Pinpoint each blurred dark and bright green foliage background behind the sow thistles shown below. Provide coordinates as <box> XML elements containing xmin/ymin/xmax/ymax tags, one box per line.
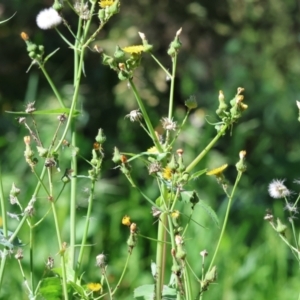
<box><xmin>0</xmin><ymin>0</ymin><xmax>300</xmax><ymax>300</ymax></box>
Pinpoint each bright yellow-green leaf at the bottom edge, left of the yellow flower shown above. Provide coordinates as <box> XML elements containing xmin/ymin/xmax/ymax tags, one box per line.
<box><xmin>38</xmin><ymin>277</ymin><xmax>62</xmax><ymax>300</ymax></box>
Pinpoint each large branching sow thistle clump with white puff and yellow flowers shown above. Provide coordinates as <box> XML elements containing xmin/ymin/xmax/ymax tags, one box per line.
<box><xmin>0</xmin><ymin>0</ymin><xmax>247</xmax><ymax>300</ymax></box>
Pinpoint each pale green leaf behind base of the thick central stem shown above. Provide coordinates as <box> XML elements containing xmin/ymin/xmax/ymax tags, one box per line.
<box><xmin>133</xmin><ymin>284</ymin><xmax>176</xmax><ymax>300</ymax></box>
